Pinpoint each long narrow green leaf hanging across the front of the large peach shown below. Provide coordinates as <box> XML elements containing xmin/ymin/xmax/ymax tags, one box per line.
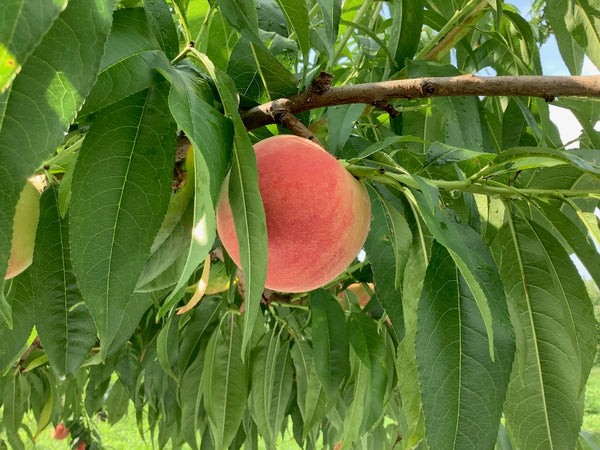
<box><xmin>196</xmin><ymin>53</ymin><xmax>268</xmax><ymax>353</ymax></box>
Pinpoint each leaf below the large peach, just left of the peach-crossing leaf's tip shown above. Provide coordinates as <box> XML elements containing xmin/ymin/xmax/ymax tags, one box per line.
<box><xmin>201</xmin><ymin>314</ymin><xmax>248</xmax><ymax>448</ymax></box>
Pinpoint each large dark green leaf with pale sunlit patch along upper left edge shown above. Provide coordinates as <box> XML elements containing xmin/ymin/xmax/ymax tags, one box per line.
<box><xmin>0</xmin><ymin>0</ymin><xmax>112</xmax><ymax>323</ymax></box>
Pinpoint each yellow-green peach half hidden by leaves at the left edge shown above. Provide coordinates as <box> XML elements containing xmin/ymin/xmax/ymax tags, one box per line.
<box><xmin>4</xmin><ymin>182</ymin><xmax>40</xmax><ymax>280</ymax></box>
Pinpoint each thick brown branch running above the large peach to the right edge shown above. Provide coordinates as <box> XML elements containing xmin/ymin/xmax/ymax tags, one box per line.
<box><xmin>242</xmin><ymin>73</ymin><xmax>600</xmax><ymax>130</ymax></box>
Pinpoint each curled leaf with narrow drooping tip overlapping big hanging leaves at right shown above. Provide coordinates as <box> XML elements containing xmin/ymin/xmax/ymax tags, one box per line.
<box><xmin>413</xmin><ymin>178</ymin><xmax>510</xmax><ymax>359</ymax></box>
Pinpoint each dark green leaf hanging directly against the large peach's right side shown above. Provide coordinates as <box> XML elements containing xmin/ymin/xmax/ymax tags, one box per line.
<box><xmin>365</xmin><ymin>189</ymin><xmax>412</xmax><ymax>338</ymax></box>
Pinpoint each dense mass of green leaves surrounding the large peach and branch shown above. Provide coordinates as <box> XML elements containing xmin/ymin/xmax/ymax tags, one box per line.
<box><xmin>0</xmin><ymin>0</ymin><xmax>600</xmax><ymax>449</ymax></box>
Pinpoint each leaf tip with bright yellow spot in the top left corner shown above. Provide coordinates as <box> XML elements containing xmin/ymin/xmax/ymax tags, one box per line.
<box><xmin>0</xmin><ymin>0</ymin><xmax>67</xmax><ymax>92</ymax></box>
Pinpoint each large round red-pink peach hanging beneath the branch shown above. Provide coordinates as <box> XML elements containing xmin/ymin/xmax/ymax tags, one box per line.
<box><xmin>217</xmin><ymin>135</ymin><xmax>371</xmax><ymax>292</ymax></box>
